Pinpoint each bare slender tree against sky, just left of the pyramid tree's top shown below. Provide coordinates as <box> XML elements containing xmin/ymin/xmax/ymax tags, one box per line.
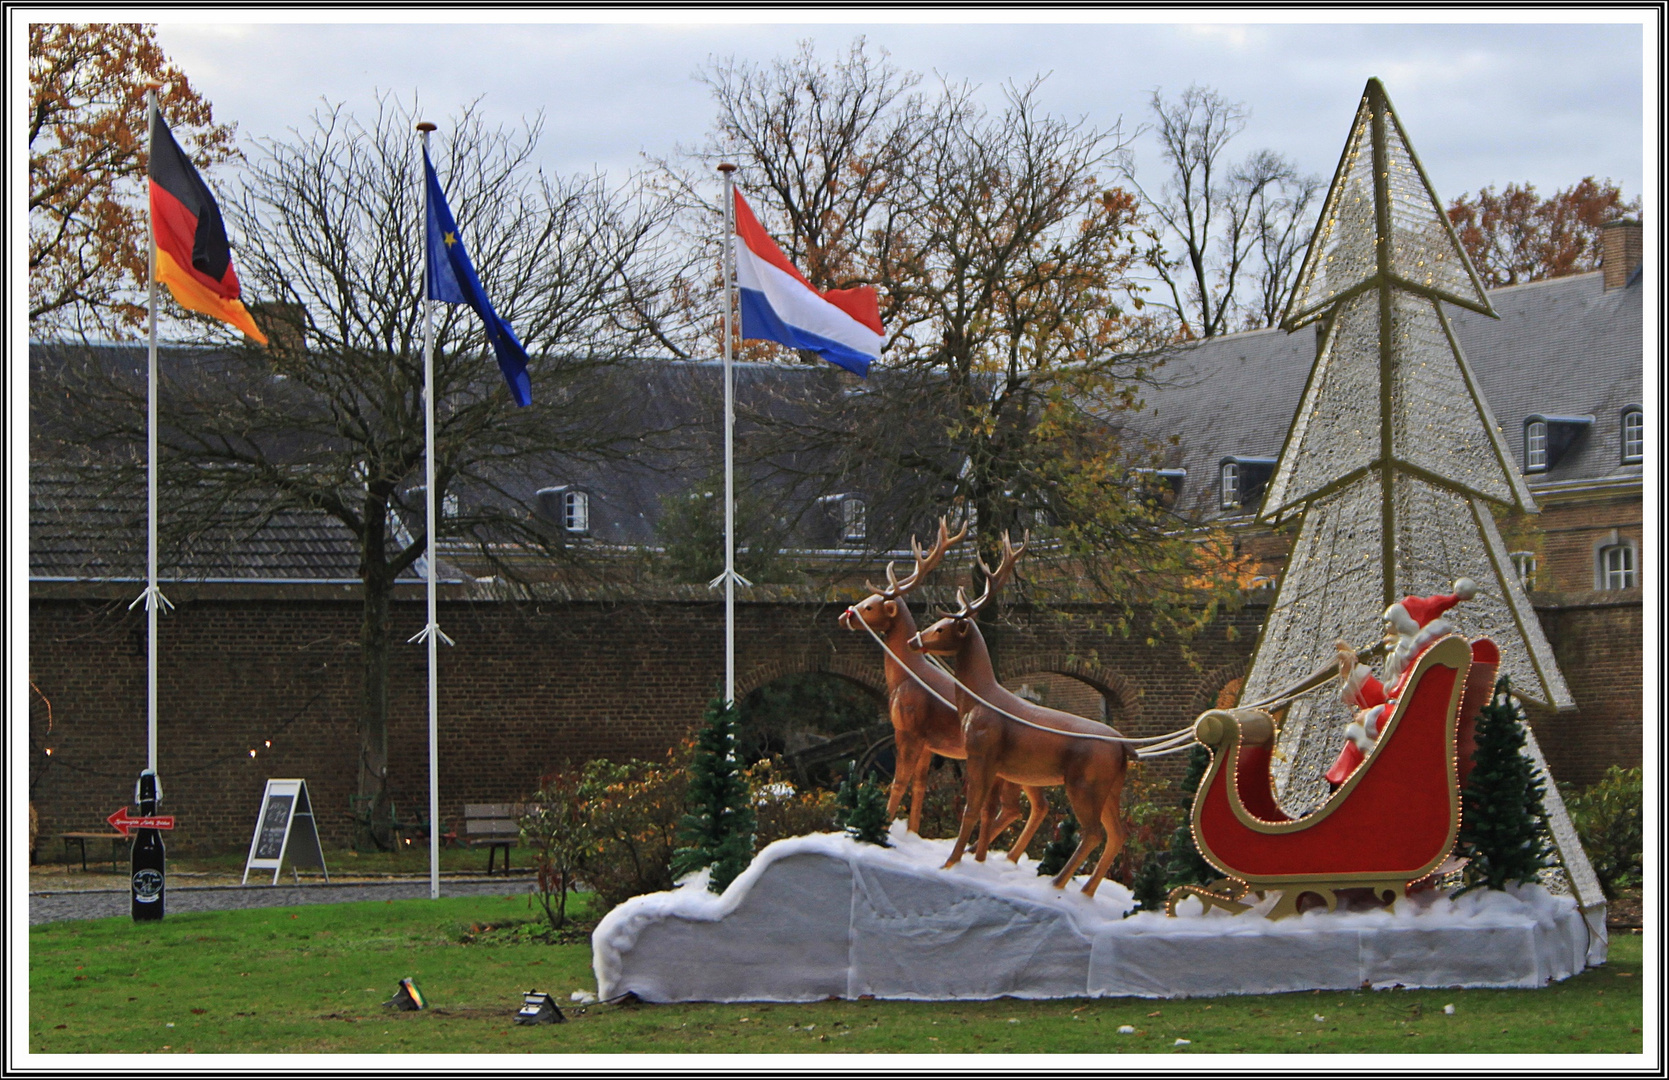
<box><xmin>1142</xmin><ymin>85</ymin><xmax>1320</xmax><ymax>337</ymax></box>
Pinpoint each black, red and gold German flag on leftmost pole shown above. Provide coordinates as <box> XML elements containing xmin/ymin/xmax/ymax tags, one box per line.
<box><xmin>149</xmin><ymin>105</ymin><xmax>267</xmax><ymax>344</ymax></box>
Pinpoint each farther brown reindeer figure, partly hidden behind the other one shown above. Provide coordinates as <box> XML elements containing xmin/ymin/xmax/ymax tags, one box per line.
<box><xmin>840</xmin><ymin>517</ymin><xmax>1020</xmax><ymax>836</ymax></box>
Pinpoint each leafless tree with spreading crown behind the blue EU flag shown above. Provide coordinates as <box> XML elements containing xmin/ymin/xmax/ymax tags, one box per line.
<box><xmin>39</xmin><ymin>98</ymin><xmax>690</xmax><ymax>837</ymax></box>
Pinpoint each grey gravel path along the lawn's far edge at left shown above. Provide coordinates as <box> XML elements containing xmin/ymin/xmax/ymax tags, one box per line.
<box><xmin>28</xmin><ymin>878</ymin><xmax>532</xmax><ymax>926</ymax></box>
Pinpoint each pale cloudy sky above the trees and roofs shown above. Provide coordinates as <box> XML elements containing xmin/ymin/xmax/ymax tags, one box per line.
<box><xmin>146</xmin><ymin>10</ymin><xmax>1656</xmax><ymax>200</ymax></box>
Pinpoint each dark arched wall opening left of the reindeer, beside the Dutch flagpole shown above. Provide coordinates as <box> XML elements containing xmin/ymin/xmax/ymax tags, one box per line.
<box><xmin>738</xmin><ymin>671</ymin><xmax>893</xmax><ymax>788</ymax></box>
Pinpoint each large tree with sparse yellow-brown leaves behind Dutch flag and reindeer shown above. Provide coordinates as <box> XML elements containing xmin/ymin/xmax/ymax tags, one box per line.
<box><xmin>691</xmin><ymin>42</ymin><xmax>1255</xmax><ymax>640</ymax></box>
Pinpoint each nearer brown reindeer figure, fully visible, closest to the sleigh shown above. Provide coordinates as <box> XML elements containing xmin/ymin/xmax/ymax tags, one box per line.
<box><xmin>910</xmin><ymin>534</ymin><xmax>1135</xmax><ymax>896</ymax></box>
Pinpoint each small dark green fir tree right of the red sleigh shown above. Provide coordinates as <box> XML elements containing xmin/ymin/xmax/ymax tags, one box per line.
<box><xmin>1455</xmin><ymin>679</ymin><xmax>1552</xmax><ymax>891</ymax></box>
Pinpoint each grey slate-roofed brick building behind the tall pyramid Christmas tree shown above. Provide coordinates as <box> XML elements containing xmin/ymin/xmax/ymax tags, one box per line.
<box><xmin>1132</xmin><ymin>237</ymin><xmax>1646</xmax><ymax>604</ymax></box>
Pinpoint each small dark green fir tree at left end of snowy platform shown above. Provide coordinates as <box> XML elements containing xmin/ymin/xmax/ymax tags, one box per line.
<box><xmin>673</xmin><ymin>698</ymin><xmax>754</xmax><ymax>893</ymax></box>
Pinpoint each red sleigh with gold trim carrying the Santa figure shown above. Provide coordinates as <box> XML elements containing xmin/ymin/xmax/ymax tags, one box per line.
<box><xmin>1167</xmin><ymin>634</ymin><xmax>1500</xmax><ymax>918</ymax></box>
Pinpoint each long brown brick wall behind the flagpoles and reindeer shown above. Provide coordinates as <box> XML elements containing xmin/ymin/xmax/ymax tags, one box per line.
<box><xmin>30</xmin><ymin>586</ymin><xmax>1641</xmax><ymax>856</ymax></box>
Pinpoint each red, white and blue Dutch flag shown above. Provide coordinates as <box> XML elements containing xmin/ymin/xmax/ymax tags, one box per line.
<box><xmin>734</xmin><ymin>192</ymin><xmax>885</xmax><ymax>377</ymax></box>
